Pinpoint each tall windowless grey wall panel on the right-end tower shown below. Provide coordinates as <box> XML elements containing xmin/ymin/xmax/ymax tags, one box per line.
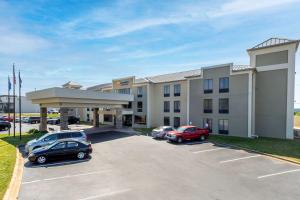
<box><xmin>255</xmin><ymin>69</ymin><xmax>287</xmax><ymax>138</ymax></box>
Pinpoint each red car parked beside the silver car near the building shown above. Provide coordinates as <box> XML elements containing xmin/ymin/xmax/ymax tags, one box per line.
<box><xmin>166</xmin><ymin>126</ymin><xmax>209</xmax><ymax>143</ymax></box>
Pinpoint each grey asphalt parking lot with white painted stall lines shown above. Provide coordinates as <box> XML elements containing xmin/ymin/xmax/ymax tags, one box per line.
<box><xmin>19</xmin><ymin>132</ymin><xmax>300</xmax><ymax>200</ymax></box>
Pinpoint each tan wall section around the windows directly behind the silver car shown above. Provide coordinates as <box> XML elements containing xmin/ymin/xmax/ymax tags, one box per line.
<box><xmin>151</xmin><ymin>81</ymin><xmax>187</xmax><ymax>127</ymax></box>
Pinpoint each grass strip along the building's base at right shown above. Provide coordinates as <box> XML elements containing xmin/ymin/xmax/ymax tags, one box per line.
<box><xmin>209</xmin><ymin>135</ymin><xmax>300</xmax><ymax>164</ymax></box>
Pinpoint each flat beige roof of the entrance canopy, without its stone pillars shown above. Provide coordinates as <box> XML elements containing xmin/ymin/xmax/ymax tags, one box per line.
<box><xmin>26</xmin><ymin>87</ymin><xmax>134</xmax><ymax>108</ymax></box>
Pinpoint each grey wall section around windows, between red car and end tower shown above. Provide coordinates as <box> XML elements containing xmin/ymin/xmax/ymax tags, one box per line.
<box><xmin>189</xmin><ymin>66</ymin><xmax>248</xmax><ymax>137</ymax></box>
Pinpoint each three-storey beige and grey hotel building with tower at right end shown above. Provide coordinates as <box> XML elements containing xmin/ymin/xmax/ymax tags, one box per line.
<box><xmin>82</xmin><ymin>38</ymin><xmax>299</xmax><ymax>138</ymax></box>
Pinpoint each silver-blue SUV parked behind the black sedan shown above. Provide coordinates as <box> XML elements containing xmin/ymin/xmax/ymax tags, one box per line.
<box><xmin>25</xmin><ymin>131</ymin><xmax>87</xmax><ymax>153</ymax></box>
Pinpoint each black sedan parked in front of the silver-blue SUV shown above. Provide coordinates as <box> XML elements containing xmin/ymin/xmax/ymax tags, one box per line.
<box><xmin>28</xmin><ymin>139</ymin><xmax>93</xmax><ymax>164</ymax></box>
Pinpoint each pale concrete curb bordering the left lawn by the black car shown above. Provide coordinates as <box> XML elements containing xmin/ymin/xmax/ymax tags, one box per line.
<box><xmin>3</xmin><ymin>147</ymin><xmax>24</xmax><ymax>200</ymax></box>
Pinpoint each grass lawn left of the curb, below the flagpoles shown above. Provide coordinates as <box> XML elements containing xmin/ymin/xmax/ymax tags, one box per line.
<box><xmin>0</xmin><ymin>133</ymin><xmax>42</xmax><ymax>199</ymax></box>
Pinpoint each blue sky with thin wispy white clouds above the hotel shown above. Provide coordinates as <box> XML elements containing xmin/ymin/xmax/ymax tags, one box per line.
<box><xmin>0</xmin><ymin>0</ymin><xmax>300</xmax><ymax>107</ymax></box>
